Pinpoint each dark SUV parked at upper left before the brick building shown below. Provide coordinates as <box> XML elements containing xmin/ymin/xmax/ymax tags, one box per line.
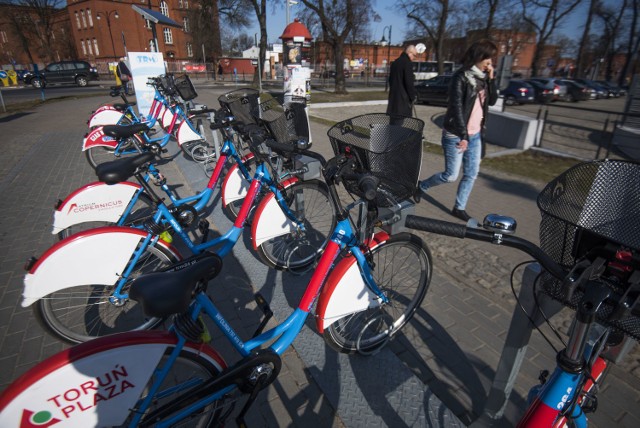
<box><xmin>23</xmin><ymin>61</ymin><xmax>100</xmax><ymax>88</ymax></box>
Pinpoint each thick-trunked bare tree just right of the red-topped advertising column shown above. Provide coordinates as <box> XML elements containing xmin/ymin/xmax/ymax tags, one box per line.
<box><xmin>302</xmin><ymin>0</ymin><xmax>371</xmax><ymax>94</ymax></box>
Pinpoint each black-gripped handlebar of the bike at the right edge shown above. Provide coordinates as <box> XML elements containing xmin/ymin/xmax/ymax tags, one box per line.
<box><xmin>405</xmin><ymin>215</ymin><xmax>567</xmax><ymax>280</ymax></box>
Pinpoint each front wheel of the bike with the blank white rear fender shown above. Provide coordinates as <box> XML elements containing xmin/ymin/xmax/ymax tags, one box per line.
<box><xmin>255</xmin><ymin>180</ymin><xmax>336</xmax><ymax>271</ymax></box>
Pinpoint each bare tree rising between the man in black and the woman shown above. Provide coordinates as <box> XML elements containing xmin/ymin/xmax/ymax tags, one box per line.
<box><xmin>398</xmin><ymin>0</ymin><xmax>450</xmax><ymax>74</ymax></box>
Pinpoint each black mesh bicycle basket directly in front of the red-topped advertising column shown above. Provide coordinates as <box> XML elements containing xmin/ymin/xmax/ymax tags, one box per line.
<box><xmin>253</xmin><ymin>97</ymin><xmax>309</xmax><ymax>145</ymax></box>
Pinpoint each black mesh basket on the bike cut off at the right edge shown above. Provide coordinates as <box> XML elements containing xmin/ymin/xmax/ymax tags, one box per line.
<box><xmin>538</xmin><ymin>160</ymin><xmax>640</xmax><ymax>339</ymax></box>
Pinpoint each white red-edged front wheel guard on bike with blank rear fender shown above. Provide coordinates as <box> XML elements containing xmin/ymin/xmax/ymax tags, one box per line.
<box><xmin>251</xmin><ymin>177</ymin><xmax>300</xmax><ymax>250</ymax></box>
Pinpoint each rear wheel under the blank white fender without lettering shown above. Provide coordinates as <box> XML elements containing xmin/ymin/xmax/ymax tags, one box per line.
<box><xmin>34</xmin><ymin>242</ymin><xmax>177</xmax><ymax>343</ymax></box>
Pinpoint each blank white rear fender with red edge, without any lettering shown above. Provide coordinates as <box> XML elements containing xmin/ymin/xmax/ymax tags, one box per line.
<box><xmin>22</xmin><ymin>226</ymin><xmax>182</xmax><ymax>307</ymax></box>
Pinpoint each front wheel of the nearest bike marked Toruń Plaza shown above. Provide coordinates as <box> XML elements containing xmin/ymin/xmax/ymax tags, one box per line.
<box><xmin>324</xmin><ymin>233</ymin><xmax>432</xmax><ymax>354</ymax></box>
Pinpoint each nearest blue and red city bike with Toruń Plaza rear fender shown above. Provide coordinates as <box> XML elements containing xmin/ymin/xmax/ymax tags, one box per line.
<box><xmin>0</xmin><ymin>115</ymin><xmax>431</xmax><ymax>427</ymax></box>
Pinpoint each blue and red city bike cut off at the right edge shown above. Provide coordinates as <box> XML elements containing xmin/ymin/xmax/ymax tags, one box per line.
<box><xmin>405</xmin><ymin>160</ymin><xmax>640</xmax><ymax>428</ymax></box>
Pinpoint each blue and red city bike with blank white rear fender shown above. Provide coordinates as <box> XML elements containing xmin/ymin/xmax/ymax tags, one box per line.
<box><xmin>22</xmin><ymin>108</ymin><xmax>335</xmax><ymax>342</ymax></box>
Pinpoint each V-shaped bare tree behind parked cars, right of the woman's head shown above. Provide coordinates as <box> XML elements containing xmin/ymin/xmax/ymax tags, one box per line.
<box><xmin>521</xmin><ymin>0</ymin><xmax>582</xmax><ymax>76</ymax></box>
